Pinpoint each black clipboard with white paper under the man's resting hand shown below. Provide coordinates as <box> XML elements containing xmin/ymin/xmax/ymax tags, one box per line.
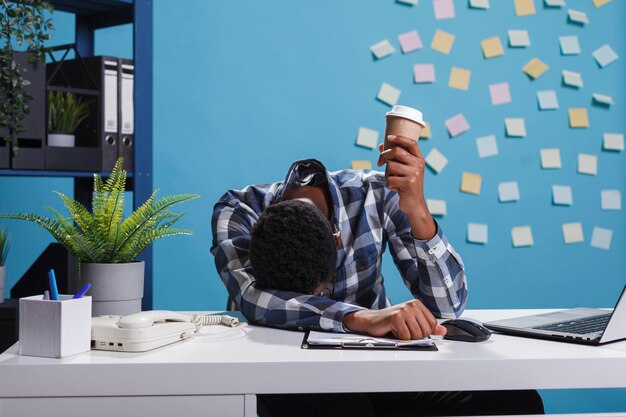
<box><xmin>301</xmin><ymin>330</ymin><xmax>439</xmax><ymax>352</ymax></box>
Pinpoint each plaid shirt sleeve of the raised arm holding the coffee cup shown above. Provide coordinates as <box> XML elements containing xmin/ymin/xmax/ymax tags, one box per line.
<box><xmin>383</xmin><ymin>190</ymin><xmax>467</xmax><ymax>318</ymax></box>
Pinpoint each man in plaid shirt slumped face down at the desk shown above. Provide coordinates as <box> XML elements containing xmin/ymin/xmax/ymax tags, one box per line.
<box><xmin>211</xmin><ymin>136</ymin><xmax>543</xmax><ymax>417</ymax></box>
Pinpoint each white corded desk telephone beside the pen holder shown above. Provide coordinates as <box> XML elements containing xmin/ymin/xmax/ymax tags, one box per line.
<box><xmin>91</xmin><ymin>310</ymin><xmax>246</xmax><ymax>352</ymax></box>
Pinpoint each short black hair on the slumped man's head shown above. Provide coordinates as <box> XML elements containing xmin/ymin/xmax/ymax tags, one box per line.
<box><xmin>250</xmin><ymin>200</ymin><xmax>337</xmax><ymax>294</ymax></box>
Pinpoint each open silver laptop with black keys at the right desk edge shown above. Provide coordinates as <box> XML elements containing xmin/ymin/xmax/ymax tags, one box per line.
<box><xmin>483</xmin><ymin>286</ymin><xmax>626</xmax><ymax>345</ymax></box>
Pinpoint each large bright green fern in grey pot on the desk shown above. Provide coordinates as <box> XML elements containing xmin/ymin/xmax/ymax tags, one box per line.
<box><xmin>0</xmin><ymin>158</ymin><xmax>199</xmax><ymax>316</ymax></box>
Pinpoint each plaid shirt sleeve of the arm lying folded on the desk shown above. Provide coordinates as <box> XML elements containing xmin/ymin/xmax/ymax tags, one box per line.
<box><xmin>211</xmin><ymin>201</ymin><xmax>362</xmax><ymax>332</ymax></box>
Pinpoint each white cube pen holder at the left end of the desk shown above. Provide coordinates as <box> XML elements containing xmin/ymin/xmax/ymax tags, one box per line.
<box><xmin>19</xmin><ymin>295</ymin><xmax>91</xmax><ymax>358</ymax></box>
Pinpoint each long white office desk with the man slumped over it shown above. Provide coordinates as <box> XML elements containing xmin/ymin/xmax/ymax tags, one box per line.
<box><xmin>0</xmin><ymin>310</ymin><xmax>626</xmax><ymax>417</ymax></box>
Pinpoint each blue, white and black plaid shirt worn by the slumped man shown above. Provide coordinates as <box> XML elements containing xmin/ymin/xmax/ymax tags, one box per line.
<box><xmin>211</xmin><ymin>160</ymin><xmax>467</xmax><ymax>332</ymax></box>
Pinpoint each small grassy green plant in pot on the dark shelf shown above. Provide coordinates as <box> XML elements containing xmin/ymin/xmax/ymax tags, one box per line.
<box><xmin>48</xmin><ymin>91</ymin><xmax>89</xmax><ymax>147</ymax></box>
